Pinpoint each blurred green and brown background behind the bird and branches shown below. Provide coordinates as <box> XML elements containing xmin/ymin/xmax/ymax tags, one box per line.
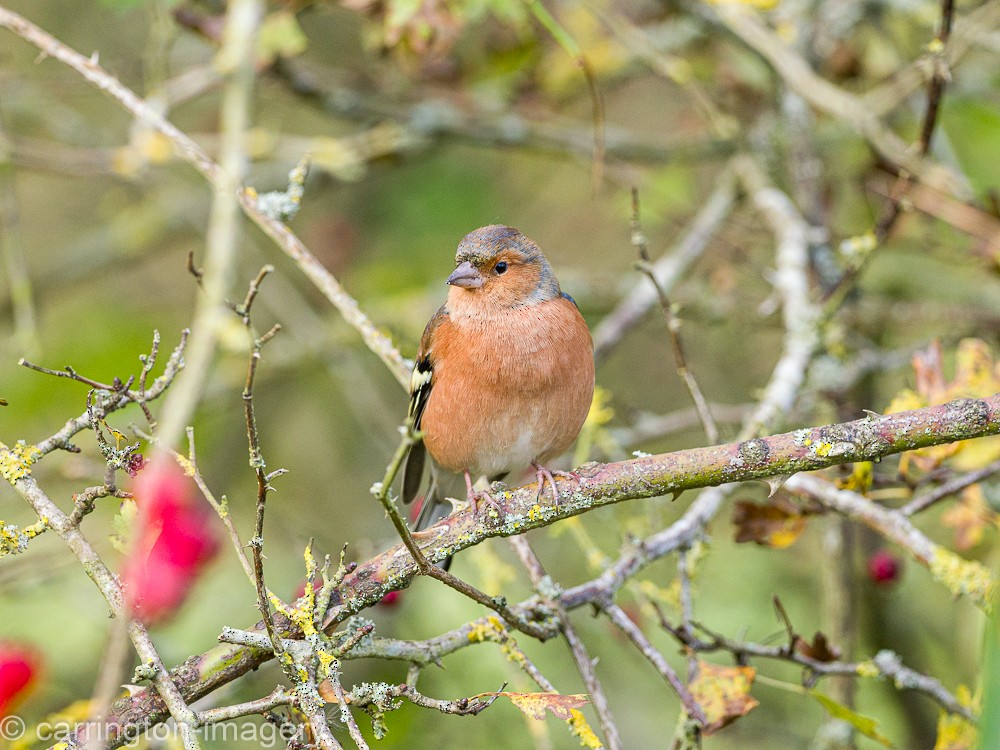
<box><xmin>0</xmin><ymin>0</ymin><xmax>1000</xmax><ymax>750</ymax></box>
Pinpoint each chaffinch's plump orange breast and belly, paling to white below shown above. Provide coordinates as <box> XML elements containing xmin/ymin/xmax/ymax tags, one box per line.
<box><xmin>421</xmin><ymin>297</ymin><xmax>594</xmax><ymax>476</ymax></box>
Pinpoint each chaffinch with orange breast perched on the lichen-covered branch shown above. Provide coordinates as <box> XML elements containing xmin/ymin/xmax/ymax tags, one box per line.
<box><xmin>402</xmin><ymin>225</ymin><xmax>594</xmax><ymax>529</ymax></box>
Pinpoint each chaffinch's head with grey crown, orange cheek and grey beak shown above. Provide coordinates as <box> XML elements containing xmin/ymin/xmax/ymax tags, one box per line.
<box><xmin>447</xmin><ymin>224</ymin><xmax>560</xmax><ymax>309</ymax></box>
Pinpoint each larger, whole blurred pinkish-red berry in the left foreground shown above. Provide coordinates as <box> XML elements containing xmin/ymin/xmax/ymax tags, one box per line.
<box><xmin>122</xmin><ymin>462</ymin><xmax>219</xmax><ymax>623</ymax></box>
